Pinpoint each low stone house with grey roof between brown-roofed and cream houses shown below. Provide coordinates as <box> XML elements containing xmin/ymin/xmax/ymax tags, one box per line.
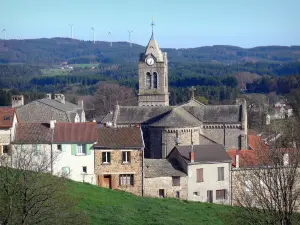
<box><xmin>144</xmin><ymin>159</ymin><xmax>188</xmax><ymax>200</ymax></box>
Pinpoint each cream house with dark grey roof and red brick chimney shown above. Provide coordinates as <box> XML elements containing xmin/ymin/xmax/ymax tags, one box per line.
<box><xmin>168</xmin><ymin>144</ymin><xmax>231</xmax><ymax>204</ymax></box>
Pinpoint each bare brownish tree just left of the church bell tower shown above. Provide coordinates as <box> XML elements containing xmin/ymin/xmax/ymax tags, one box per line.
<box><xmin>94</xmin><ymin>82</ymin><xmax>137</xmax><ymax>115</ymax></box>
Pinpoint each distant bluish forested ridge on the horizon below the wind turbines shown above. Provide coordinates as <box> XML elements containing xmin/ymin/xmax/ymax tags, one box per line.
<box><xmin>0</xmin><ymin>38</ymin><xmax>300</xmax><ymax>65</ymax></box>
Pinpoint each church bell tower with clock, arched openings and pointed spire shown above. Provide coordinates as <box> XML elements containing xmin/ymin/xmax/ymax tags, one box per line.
<box><xmin>138</xmin><ymin>20</ymin><xmax>169</xmax><ymax>106</ymax></box>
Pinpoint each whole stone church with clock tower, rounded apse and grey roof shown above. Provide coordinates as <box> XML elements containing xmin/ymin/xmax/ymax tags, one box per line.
<box><xmin>102</xmin><ymin>28</ymin><xmax>248</xmax><ymax>158</ymax></box>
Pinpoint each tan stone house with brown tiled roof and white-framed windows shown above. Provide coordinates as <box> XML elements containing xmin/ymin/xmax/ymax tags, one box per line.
<box><xmin>94</xmin><ymin>127</ymin><xmax>144</xmax><ymax>195</ymax></box>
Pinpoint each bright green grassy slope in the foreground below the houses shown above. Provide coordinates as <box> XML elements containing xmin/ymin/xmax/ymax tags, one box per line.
<box><xmin>70</xmin><ymin>182</ymin><xmax>239</xmax><ymax>225</ymax></box>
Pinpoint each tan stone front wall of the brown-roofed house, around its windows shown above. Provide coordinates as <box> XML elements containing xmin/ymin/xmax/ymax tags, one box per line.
<box><xmin>95</xmin><ymin>149</ymin><xmax>143</xmax><ymax>195</ymax></box>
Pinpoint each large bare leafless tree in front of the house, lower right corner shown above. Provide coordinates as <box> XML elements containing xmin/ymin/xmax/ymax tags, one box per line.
<box><xmin>232</xmin><ymin>118</ymin><xmax>300</xmax><ymax>225</ymax></box>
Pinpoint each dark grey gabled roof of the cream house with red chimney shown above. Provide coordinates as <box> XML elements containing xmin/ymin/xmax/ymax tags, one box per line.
<box><xmin>170</xmin><ymin>144</ymin><xmax>231</xmax><ymax>163</ymax></box>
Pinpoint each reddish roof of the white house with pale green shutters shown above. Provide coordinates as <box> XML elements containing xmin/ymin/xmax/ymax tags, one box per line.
<box><xmin>53</xmin><ymin>122</ymin><xmax>98</xmax><ymax>143</ymax></box>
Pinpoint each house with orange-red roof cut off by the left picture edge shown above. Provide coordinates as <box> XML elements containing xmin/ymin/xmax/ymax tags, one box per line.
<box><xmin>0</xmin><ymin>108</ymin><xmax>18</xmax><ymax>156</ymax></box>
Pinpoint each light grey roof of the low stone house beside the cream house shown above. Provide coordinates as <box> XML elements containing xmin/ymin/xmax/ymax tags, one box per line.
<box><xmin>144</xmin><ymin>159</ymin><xmax>186</xmax><ymax>178</ymax></box>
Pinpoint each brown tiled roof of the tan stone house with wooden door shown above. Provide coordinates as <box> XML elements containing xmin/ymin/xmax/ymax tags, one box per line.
<box><xmin>94</xmin><ymin>127</ymin><xmax>144</xmax><ymax>149</ymax></box>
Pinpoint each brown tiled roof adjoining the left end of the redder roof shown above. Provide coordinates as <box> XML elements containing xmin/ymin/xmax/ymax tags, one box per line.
<box><xmin>13</xmin><ymin>123</ymin><xmax>52</xmax><ymax>144</ymax></box>
